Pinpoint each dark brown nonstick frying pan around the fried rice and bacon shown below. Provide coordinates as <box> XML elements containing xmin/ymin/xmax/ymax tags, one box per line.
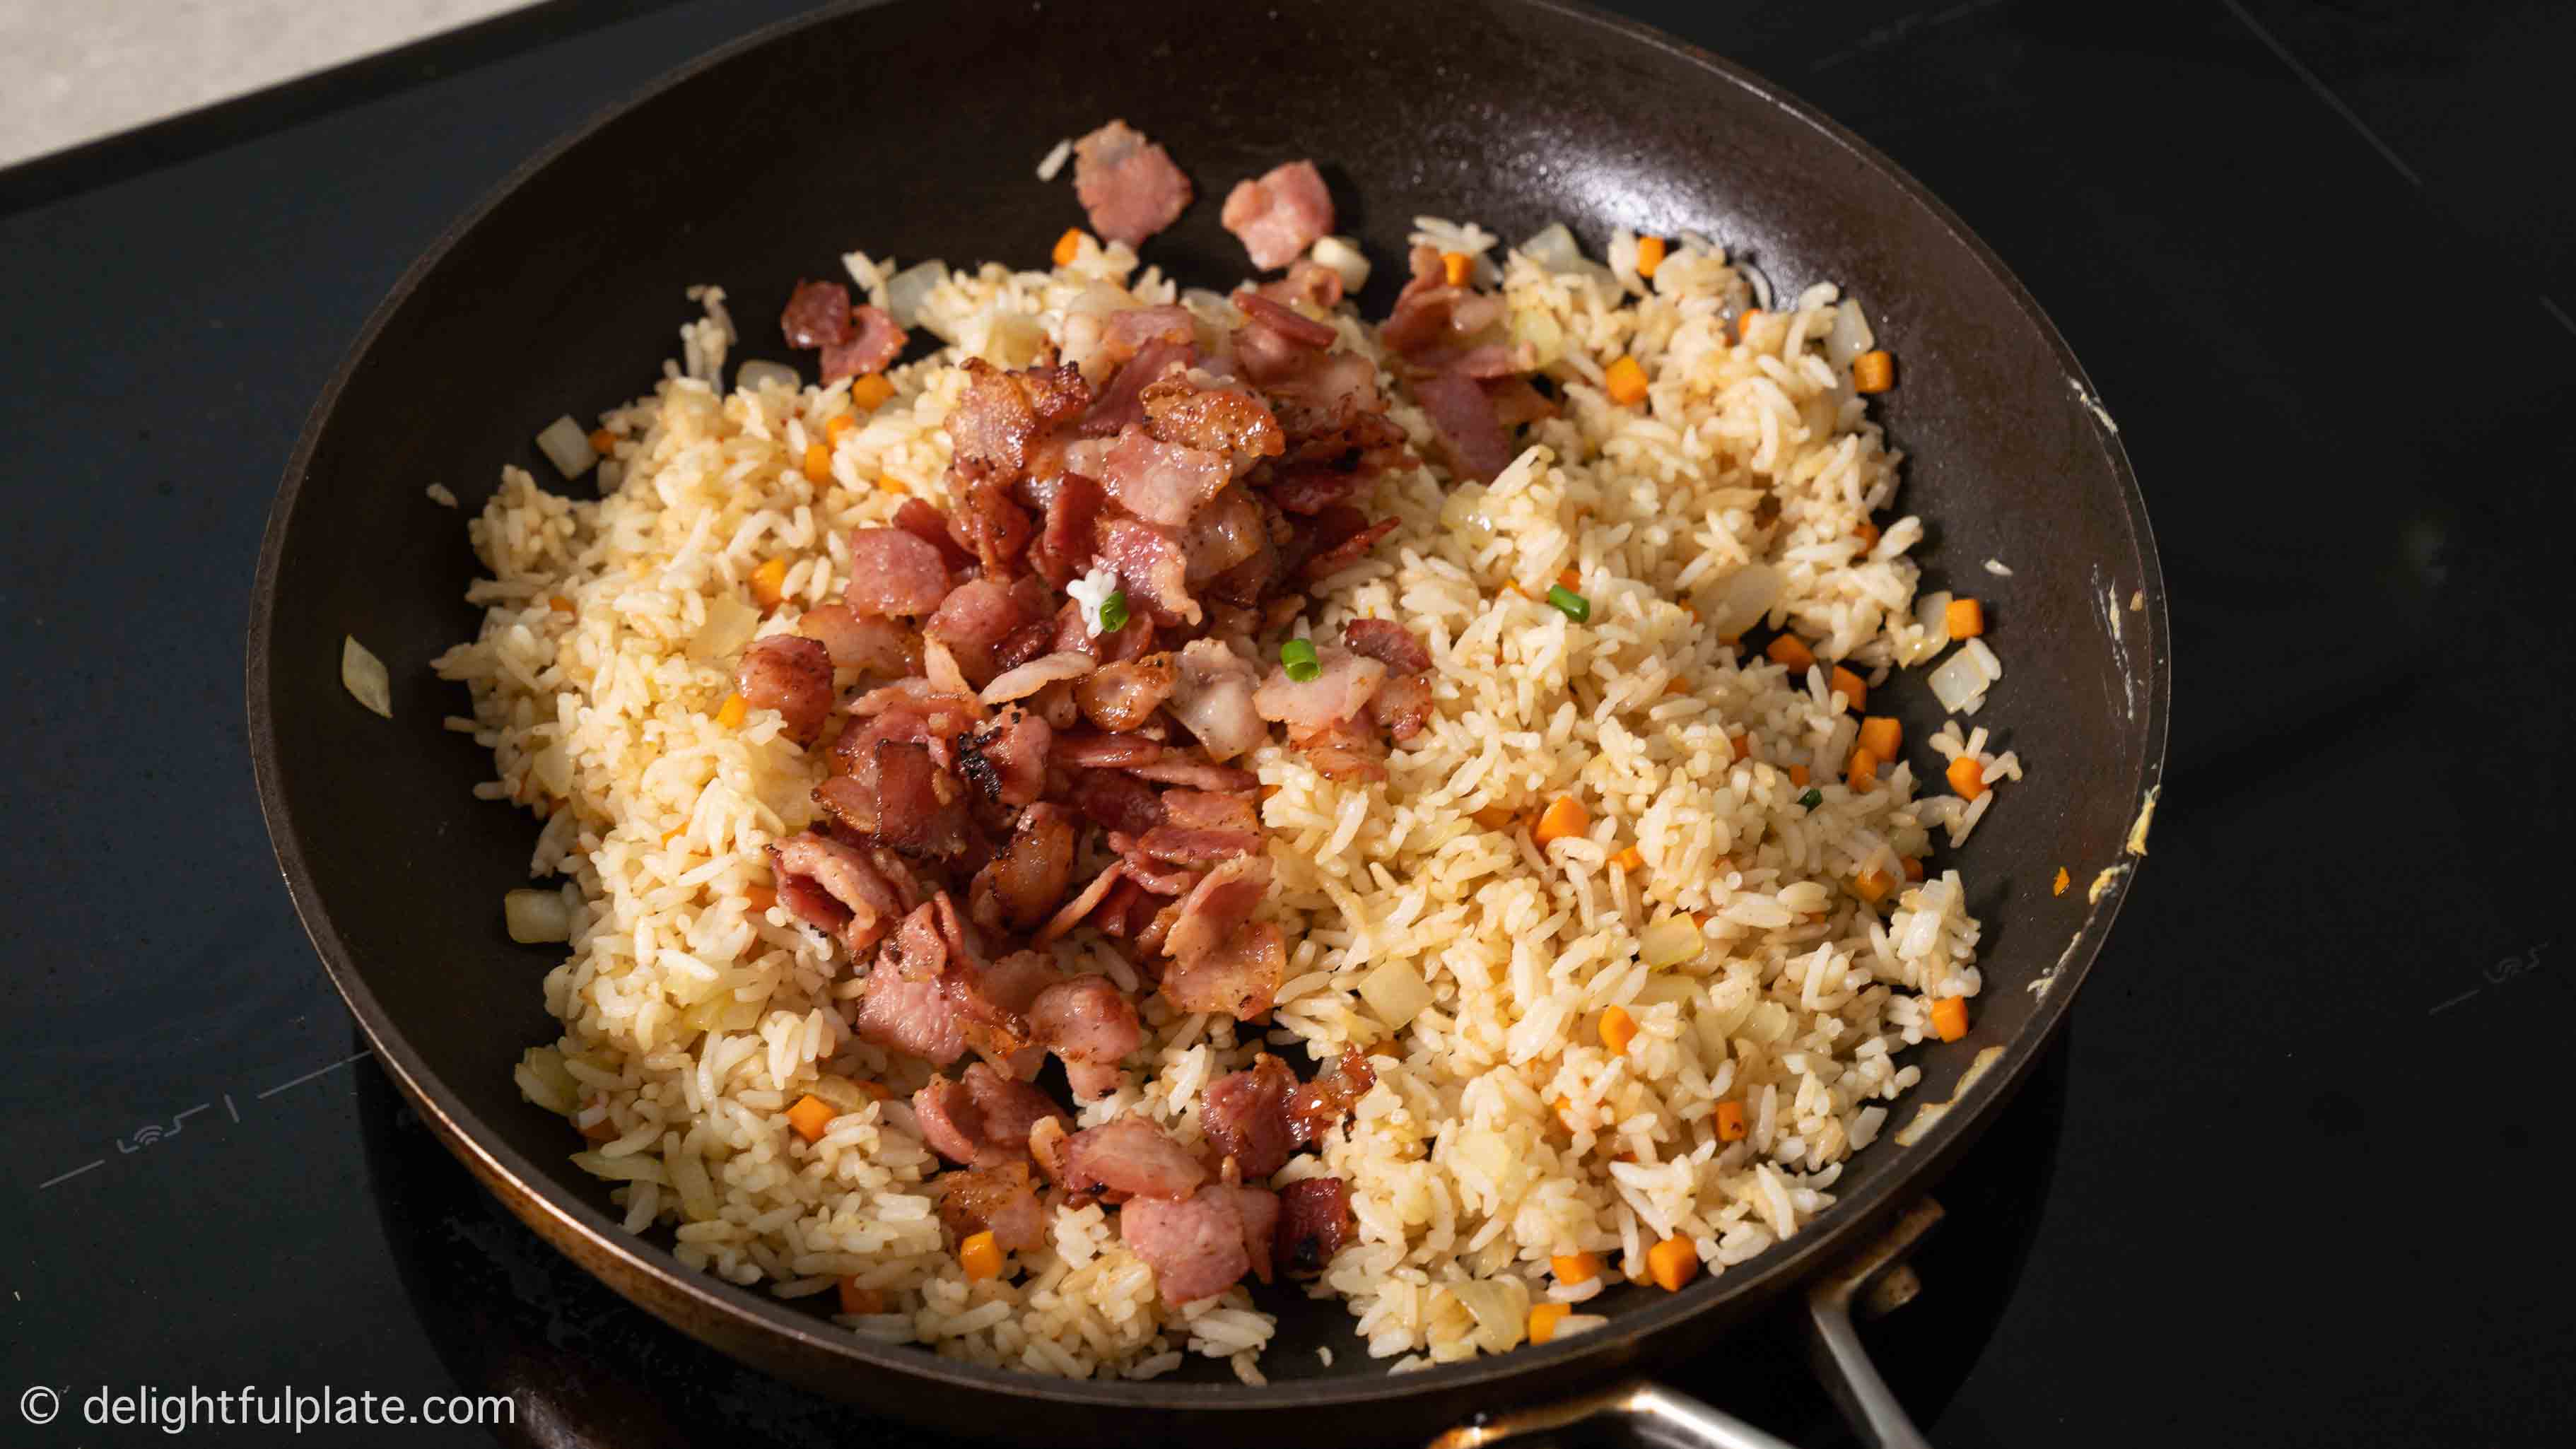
<box><xmin>247</xmin><ymin>0</ymin><xmax>2167</xmax><ymax>1444</ymax></box>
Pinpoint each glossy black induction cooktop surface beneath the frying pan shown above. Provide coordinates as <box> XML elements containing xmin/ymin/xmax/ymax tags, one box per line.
<box><xmin>0</xmin><ymin>0</ymin><xmax>2576</xmax><ymax>1449</ymax></box>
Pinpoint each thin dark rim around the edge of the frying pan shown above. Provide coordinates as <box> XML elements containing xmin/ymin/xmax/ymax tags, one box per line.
<box><xmin>245</xmin><ymin>0</ymin><xmax>2172</xmax><ymax>1413</ymax></box>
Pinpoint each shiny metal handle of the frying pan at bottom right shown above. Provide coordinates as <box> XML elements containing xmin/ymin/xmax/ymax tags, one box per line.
<box><xmin>1429</xmin><ymin>1197</ymin><xmax>1940</xmax><ymax>1449</ymax></box>
